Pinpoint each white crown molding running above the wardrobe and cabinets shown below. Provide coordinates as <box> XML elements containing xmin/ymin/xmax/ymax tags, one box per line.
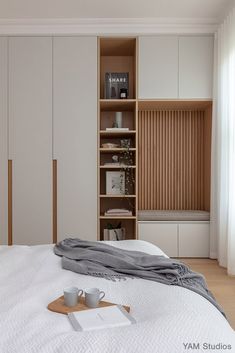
<box><xmin>0</xmin><ymin>18</ymin><xmax>218</xmax><ymax>36</ymax></box>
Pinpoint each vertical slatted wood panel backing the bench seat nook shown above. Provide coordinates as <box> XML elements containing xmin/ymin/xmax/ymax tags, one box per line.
<box><xmin>138</xmin><ymin>110</ymin><xmax>205</xmax><ymax>210</ymax></box>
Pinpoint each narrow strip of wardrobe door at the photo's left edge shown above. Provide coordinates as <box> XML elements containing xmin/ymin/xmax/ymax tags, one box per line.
<box><xmin>0</xmin><ymin>37</ymin><xmax>8</xmax><ymax>244</ymax></box>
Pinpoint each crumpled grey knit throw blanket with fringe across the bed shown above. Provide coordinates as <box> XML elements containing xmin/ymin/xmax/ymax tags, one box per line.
<box><xmin>54</xmin><ymin>238</ymin><xmax>225</xmax><ymax>316</ymax></box>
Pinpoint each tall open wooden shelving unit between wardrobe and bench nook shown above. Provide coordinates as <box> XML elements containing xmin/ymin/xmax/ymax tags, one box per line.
<box><xmin>98</xmin><ymin>37</ymin><xmax>138</xmax><ymax>240</ymax></box>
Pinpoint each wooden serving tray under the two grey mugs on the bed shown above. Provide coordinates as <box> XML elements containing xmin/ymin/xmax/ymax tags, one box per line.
<box><xmin>47</xmin><ymin>295</ymin><xmax>130</xmax><ymax>314</ymax></box>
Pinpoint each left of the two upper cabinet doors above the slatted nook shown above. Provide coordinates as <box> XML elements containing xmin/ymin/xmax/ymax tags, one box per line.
<box><xmin>139</xmin><ymin>36</ymin><xmax>178</xmax><ymax>99</ymax></box>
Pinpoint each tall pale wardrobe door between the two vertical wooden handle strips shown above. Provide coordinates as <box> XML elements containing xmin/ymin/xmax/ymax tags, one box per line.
<box><xmin>9</xmin><ymin>37</ymin><xmax>52</xmax><ymax>244</ymax></box>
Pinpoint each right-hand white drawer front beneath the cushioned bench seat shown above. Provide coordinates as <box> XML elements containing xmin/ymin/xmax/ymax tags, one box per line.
<box><xmin>179</xmin><ymin>223</ymin><xmax>210</xmax><ymax>257</ymax></box>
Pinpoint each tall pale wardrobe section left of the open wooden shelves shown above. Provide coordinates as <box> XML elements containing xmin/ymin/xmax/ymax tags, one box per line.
<box><xmin>0</xmin><ymin>36</ymin><xmax>97</xmax><ymax>245</ymax></box>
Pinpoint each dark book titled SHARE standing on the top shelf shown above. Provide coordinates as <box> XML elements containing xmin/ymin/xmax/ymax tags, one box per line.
<box><xmin>104</xmin><ymin>72</ymin><xmax>129</xmax><ymax>99</ymax></box>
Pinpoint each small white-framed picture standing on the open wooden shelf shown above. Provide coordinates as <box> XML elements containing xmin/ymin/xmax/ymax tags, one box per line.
<box><xmin>106</xmin><ymin>171</ymin><xmax>125</xmax><ymax>195</ymax></box>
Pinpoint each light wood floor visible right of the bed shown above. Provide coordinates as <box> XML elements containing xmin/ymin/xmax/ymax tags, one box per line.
<box><xmin>180</xmin><ymin>258</ymin><xmax>235</xmax><ymax>330</ymax></box>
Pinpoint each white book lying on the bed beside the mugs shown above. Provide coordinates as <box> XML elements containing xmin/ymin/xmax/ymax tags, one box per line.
<box><xmin>68</xmin><ymin>305</ymin><xmax>136</xmax><ymax>331</ymax></box>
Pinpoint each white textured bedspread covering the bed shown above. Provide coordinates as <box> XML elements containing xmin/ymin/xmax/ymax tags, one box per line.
<box><xmin>0</xmin><ymin>240</ymin><xmax>235</xmax><ymax>353</ymax></box>
